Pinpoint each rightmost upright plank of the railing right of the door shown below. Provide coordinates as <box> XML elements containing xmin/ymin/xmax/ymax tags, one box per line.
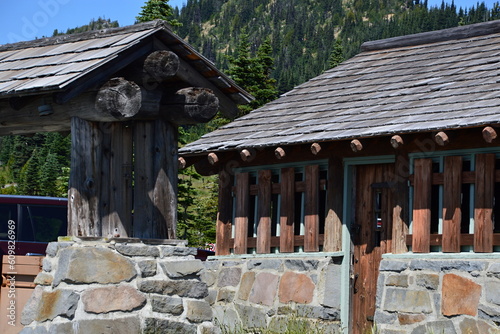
<box><xmin>474</xmin><ymin>154</ymin><xmax>495</xmax><ymax>253</ymax></box>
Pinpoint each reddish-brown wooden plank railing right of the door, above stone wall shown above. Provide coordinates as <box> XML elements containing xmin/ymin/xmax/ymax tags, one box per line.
<box><xmin>406</xmin><ymin>154</ymin><xmax>500</xmax><ymax>253</ymax></box>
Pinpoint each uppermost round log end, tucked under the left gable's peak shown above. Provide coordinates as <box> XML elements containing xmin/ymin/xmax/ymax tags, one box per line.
<box><xmin>143</xmin><ymin>50</ymin><xmax>180</xmax><ymax>82</ymax></box>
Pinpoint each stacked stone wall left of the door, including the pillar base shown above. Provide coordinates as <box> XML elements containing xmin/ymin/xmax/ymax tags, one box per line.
<box><xmin>17</xmin><ymin>238</ymin><xmax>341</xmax><ymax>334</ymax></box>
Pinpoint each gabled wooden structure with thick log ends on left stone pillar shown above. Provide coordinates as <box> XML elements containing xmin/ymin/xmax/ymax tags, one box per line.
<box><xmin>0</xmin><ymin>21</ymin><xmax>252</xmax><ymax>238</ymax></box>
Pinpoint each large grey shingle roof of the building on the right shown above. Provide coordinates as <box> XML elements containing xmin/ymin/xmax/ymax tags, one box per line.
<box><xmin>179</xmin><ymin>21</ymin><xmax>500</xmax><ymax>155</ymax></box>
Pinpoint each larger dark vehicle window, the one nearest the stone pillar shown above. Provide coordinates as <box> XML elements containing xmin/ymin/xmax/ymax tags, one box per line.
<box><xmin>18</xmin><ymin>205</ymin><xmax>67</xmax><ymax>242</ymax></box>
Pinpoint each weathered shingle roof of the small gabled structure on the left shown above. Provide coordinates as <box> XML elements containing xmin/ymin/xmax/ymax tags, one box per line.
<box><xmin>0</xmin><ymin>20</ymin><xmax>252</xmax><ymax>103</ymax></box>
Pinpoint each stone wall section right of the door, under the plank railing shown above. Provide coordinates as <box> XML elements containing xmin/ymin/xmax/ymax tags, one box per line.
<box><xmin>375</xmin><ymin>259</ymin><xmax>500</xmax><ymax>334</ymax></box>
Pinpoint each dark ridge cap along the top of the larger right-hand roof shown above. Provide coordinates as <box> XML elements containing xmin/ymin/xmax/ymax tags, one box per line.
<box><xmin>361</xmin><ymin>20</ymin><xmax>500</xmax><ymax>52</ymax></box>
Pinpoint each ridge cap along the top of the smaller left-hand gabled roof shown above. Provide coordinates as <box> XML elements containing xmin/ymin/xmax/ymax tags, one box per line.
<box><xmin>0</xmin><ymin>20</ymin><xmax>172</xmax><ymax>52</ymax></box>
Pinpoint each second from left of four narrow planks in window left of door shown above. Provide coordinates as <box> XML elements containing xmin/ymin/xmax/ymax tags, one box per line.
<box><xmin>257</xmin><ymin>170</ymin><xmax>271</xmax><ymax>254</ymax></box>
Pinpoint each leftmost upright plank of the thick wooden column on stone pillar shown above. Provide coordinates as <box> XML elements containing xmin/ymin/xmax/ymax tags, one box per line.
<box><xmin>68</xmin><ymin>117</ymin><xmax>102</xmax><ymax>236</ymax></box>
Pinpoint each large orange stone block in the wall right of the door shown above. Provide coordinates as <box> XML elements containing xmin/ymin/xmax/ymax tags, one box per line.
<box><xmin>441</xmin><ymin>274</ymin><xmax>482</xmax><ymax>316</ymax></box>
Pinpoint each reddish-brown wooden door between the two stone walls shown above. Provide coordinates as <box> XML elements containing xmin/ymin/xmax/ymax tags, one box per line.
<box><xmin>351</xmin><ymin>164</ymin><xmax>394</xmax><ymax>334</ymax></box>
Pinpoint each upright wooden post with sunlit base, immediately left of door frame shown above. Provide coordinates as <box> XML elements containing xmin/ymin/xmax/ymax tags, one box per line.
<box><xmin>323</xmin><ymin>157</ymin><xmax>344</xmax><ymax>252</ymax></box>
